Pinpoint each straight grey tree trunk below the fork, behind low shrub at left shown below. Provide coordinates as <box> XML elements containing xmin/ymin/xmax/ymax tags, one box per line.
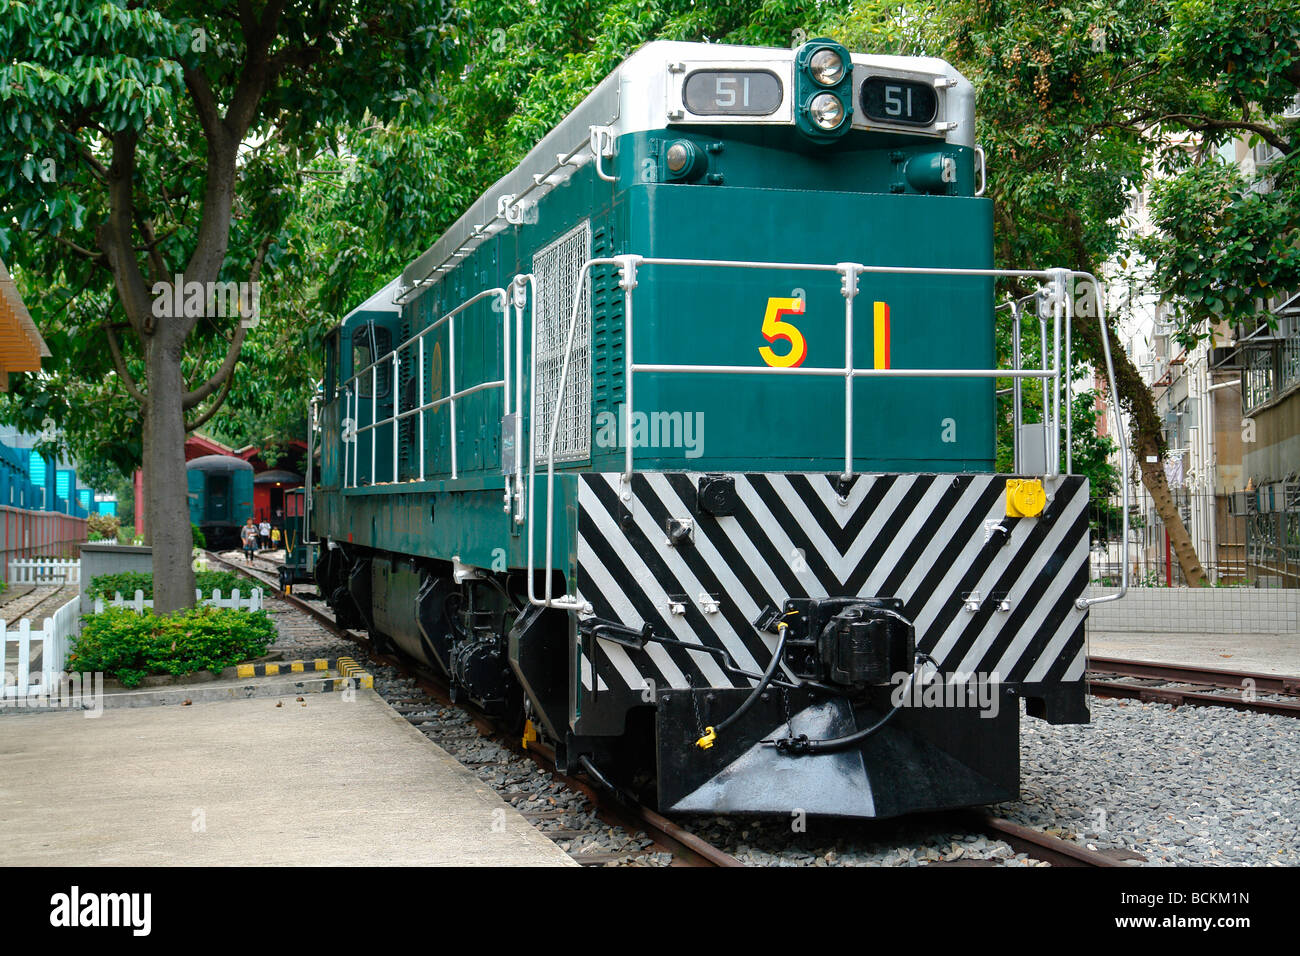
<box><xmin>144</xmin><ymin>329</ymin><xmax>194</xmax><ymax>614</ymax></box>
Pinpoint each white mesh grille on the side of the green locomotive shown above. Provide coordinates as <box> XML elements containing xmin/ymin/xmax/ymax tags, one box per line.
<box><xmin>533</xmin><ymin>220</ymin><xmax>592</xmax><ymax>462</ymax></box>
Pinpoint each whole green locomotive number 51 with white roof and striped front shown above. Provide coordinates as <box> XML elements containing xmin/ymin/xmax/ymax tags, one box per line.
<box><xmin>309</xmin><ymin>40</ymin><xmax>1123</xmax><ymax>817</ymax></box>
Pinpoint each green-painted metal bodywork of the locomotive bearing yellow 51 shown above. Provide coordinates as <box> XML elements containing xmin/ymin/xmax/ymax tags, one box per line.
<box><xmin>313</xmin><ymin>126</ymin><xmax>995</xmax><ymax>570</ymax></box>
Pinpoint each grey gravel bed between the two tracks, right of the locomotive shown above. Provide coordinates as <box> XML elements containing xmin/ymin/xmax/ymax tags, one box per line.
<box><xmin>993</xmin><ymin>697</ymin><xmax>1300</xmax><ymax>866</ymax></box>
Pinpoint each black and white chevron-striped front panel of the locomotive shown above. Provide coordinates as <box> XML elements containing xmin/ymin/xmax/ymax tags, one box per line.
<box><xmin>577</xmin><ymin>473</ymin><xmax>1088</xmax><ymax>689</ymax></box>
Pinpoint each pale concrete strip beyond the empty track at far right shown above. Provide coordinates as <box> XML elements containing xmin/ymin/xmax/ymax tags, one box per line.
<box><xmin>1088</xmin><ymin>631</ymin><xmax>1300</xmax><ymax>676</ymax></box>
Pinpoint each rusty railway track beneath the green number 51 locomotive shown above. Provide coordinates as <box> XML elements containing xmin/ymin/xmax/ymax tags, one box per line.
<box><xmin>207</xmin><ymin>551</ymin><xmax>1123</xmax><ymax>866</ymax></box>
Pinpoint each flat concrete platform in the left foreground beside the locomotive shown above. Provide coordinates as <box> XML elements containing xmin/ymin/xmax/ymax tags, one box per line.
<box><xmin>0</xmin><ymin>689</ymin><xmax>577</xmax><ymax>866</ymax></box>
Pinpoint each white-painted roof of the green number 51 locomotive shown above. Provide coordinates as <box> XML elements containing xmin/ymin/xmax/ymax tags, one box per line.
<box><xmin>400</xmin><ymin>40</ymin><xmax>975</xmax><ymax>303</ymax></box>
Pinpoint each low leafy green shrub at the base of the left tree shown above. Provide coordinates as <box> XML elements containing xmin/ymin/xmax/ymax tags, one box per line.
<box><xmin>66</xmin><ymin>607</ymin><xmax>276</xmax><ymax>687</ymax></box>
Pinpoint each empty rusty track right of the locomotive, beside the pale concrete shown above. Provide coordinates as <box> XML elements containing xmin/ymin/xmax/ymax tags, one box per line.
<box><xmin>1088</xmin><ymin>657</ymin><xmax>1300</xmax><ymax>717</ymax></box>
